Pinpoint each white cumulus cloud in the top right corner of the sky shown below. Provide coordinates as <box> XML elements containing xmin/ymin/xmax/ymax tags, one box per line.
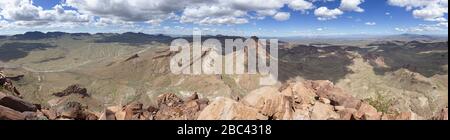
<box><xmin>388</xmin><ymin>0</ymin><xmax>448</xmax><ymax>22</ymax></box>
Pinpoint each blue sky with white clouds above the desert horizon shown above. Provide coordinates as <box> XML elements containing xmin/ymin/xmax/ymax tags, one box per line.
<box><xmin>0</xmin><ymin>0</ymin><xmax>448</xmax><ymax>37</ymax></box>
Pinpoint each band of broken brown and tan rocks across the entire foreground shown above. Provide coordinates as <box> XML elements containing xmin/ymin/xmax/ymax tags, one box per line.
<box><xmin>0</xmin><ymin>71</ymin><xmax>448</xmax><ymax>120</ymax></box>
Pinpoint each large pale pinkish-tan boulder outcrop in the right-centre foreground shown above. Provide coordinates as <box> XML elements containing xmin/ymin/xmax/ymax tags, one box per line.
<box><xmin>198</xmin><ymin>81</ymin><xmax>442</xmax><ymax>120</ymax></box>
